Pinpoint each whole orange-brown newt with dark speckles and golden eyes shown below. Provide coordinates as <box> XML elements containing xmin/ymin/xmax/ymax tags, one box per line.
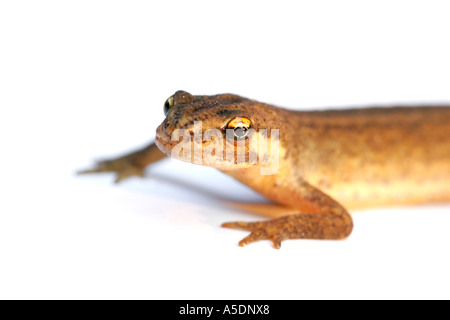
<box><xmin>80</xmin><ymin>91</ymin><xmax>450</xmax><ymax>248</ymax></box>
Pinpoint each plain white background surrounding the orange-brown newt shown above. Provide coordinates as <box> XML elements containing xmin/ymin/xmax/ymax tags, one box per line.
<box><xmin>0</xmin><ymin>0</ymin><xmax>450</xmax><ymax>299</ymax></box>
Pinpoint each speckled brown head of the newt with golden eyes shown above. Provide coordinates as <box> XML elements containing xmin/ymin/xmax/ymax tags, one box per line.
<box><xmin>156</xmin><ymin>91</ymin><xmax>282</xmax><ymax>170</ymax></box>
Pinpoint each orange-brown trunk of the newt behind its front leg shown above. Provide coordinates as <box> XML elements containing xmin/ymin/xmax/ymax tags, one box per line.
<box><xmin>287</xmin><ymin>107</ymin><xmax>450</xmax><ymax>208</ymax></box>
